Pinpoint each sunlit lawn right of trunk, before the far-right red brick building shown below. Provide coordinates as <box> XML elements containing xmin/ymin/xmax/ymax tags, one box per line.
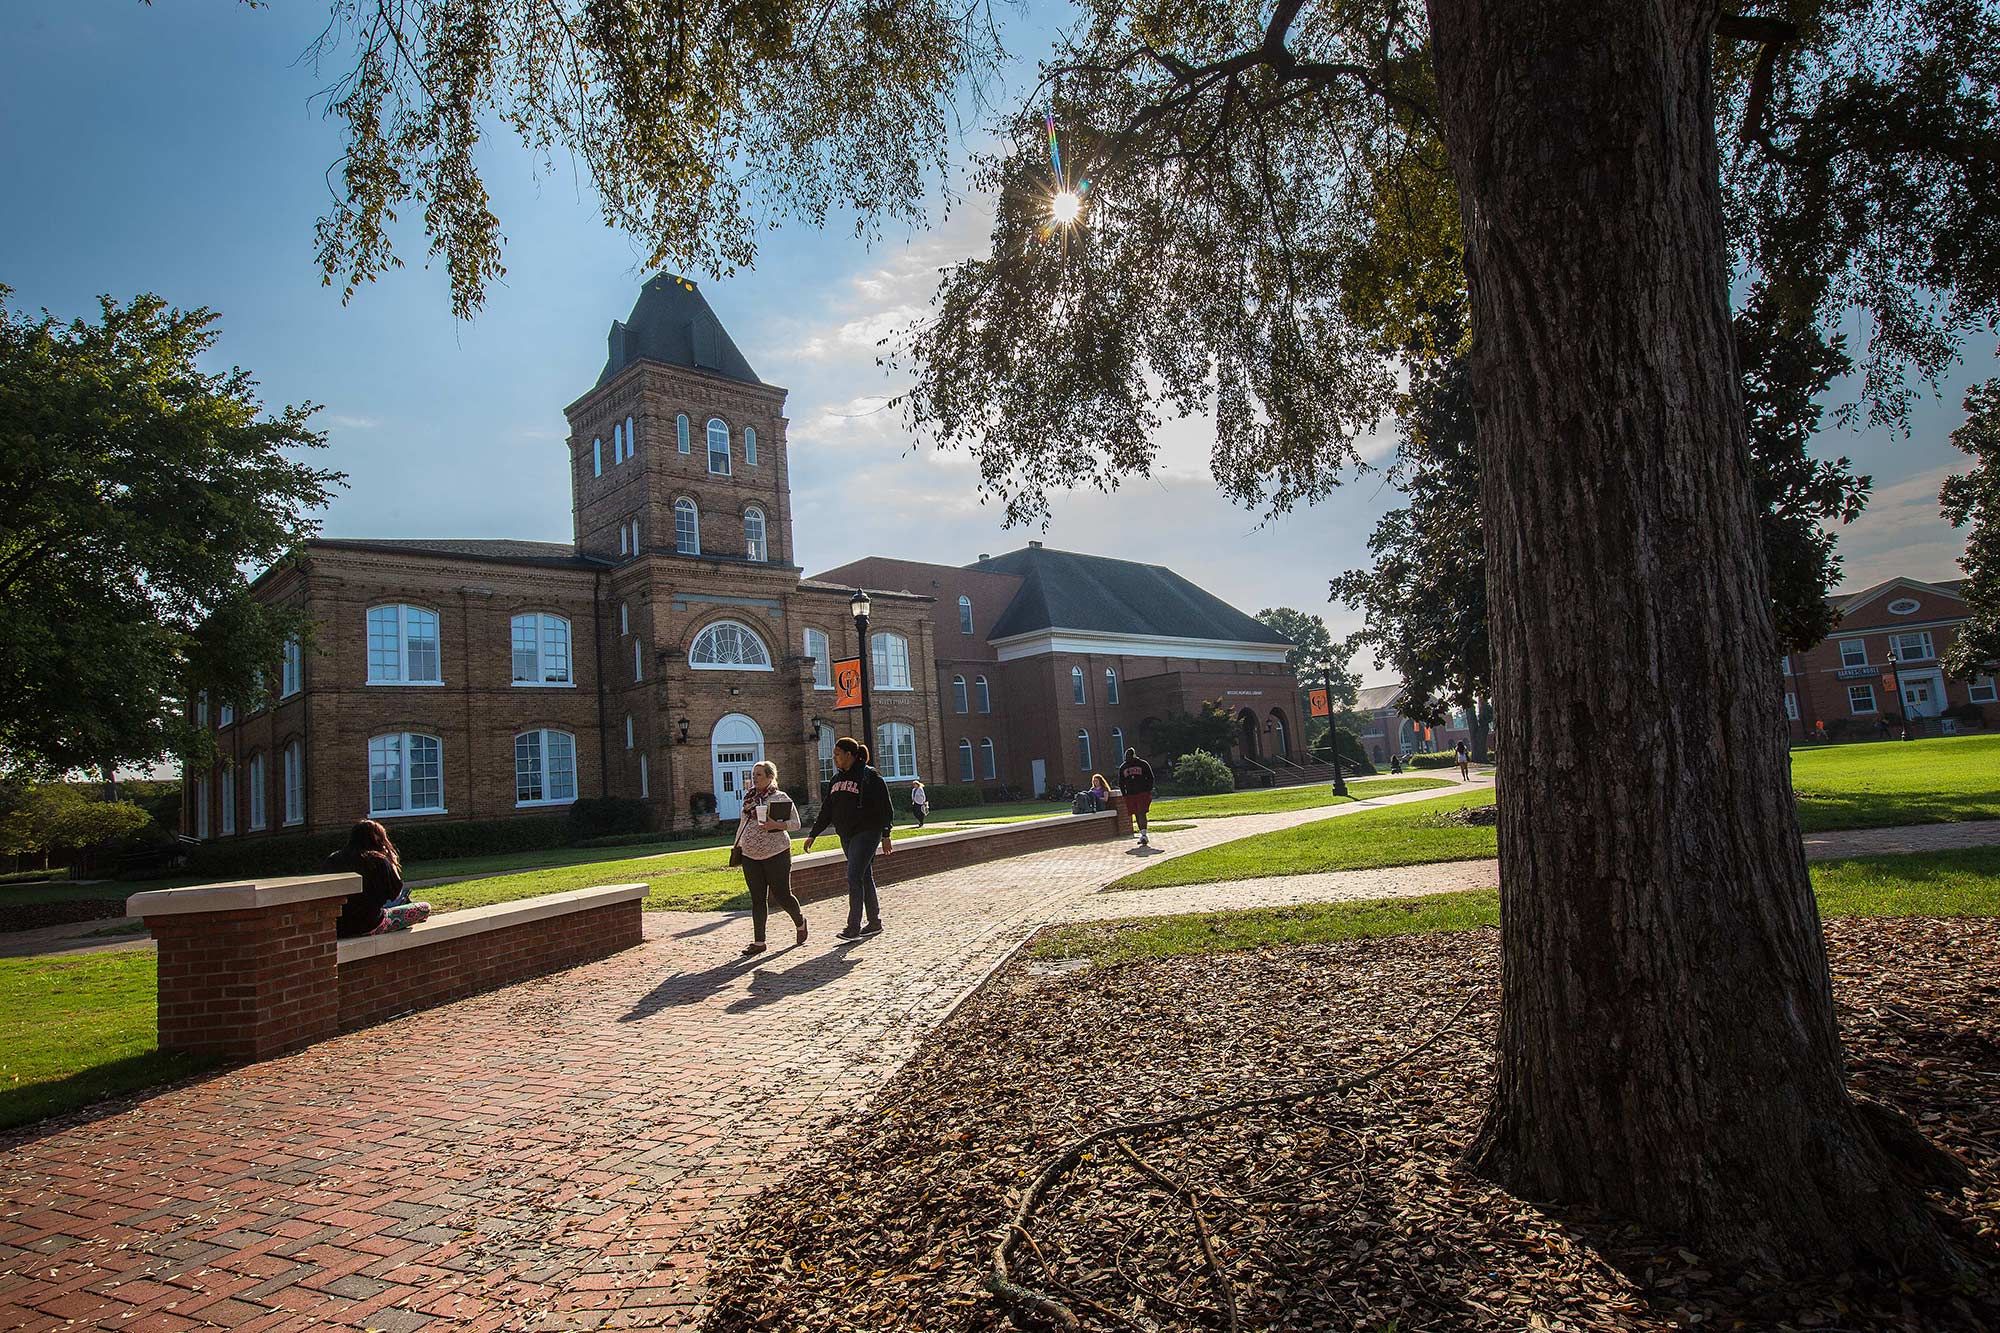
<box><xmin>1792</xmin><ymin>735</ymin><xmax>2000</xmax><ymax>833</ymax></box>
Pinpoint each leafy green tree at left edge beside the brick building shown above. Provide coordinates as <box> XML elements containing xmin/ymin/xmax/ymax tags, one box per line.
<box><xmin>0</xmin><ymin>286</ymin><xmax>340</xmax><ymax>779</ymax></box>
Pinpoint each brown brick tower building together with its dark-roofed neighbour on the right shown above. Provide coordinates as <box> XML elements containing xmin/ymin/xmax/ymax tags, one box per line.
<box><xmin>184</xmin><ymin>274</ymin><xmax>1300</xmax><ymax>839</ymax></box>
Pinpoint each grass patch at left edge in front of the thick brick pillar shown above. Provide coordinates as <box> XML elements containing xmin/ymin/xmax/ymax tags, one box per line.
<box><xmin>0</xmin><ymin>951</ymin><xmax>219</xmax><ymax>1129</ymax></box>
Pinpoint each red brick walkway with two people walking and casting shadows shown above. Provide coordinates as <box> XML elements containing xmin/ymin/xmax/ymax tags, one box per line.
<box><xmin>0</xmin><ymin>789</ymin><xmax>1452</xmax><ymax>1333</ymax></box>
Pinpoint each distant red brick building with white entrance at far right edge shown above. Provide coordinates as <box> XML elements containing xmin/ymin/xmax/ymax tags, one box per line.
<box><xmin>1780</xmin><ymin>578</ymin><xmax>2000</xmax><ymax>741</ymax></box>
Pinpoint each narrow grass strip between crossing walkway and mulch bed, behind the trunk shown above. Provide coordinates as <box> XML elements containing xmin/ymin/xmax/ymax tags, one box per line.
<box><xmin>1030</xmin><ymin>847</ymin><xmax>2000</xmax><ymax>965</ymax></box>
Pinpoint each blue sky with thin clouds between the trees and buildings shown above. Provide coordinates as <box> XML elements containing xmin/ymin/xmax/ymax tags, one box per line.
<box><xmin>0</xmin><ymin>0</ymin><xmax>1996</xmax><ymax>683</ymax></box>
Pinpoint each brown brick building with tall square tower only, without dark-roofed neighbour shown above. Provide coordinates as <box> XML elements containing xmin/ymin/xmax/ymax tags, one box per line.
<box><xmin>184</xmin><ymin>274</ymin><xmax>942</xmax><ymax>839</ymax></box>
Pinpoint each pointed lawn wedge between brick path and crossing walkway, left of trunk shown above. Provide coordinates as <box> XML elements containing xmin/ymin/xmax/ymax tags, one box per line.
<box><xmin>1112</xmin><ymin>787</ymin><xmax>1500</xmax><ymax>889</ymax></box>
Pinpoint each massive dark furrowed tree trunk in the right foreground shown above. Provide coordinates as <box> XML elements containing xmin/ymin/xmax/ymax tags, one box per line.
<box><xmin>1430</xmin><ymin>0</ymin><xmax>1948</xmax><ymax>1267</ymax></box>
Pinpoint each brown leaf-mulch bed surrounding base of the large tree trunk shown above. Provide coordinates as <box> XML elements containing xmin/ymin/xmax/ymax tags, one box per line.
<box><xmin>706</xmin><ymin>921</ymin><xmax>2000</xmax><ymax>1333</ymax></box>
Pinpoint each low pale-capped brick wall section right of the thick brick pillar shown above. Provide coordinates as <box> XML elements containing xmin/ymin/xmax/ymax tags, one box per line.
<box><xmin>340</xmin><ymin>885</ymin><xmax>646</xmax><ymax>1033</ymax></box>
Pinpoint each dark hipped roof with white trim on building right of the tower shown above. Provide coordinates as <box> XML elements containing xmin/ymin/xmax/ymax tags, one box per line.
<box><xmin>966</xmin><ymin>546</ymin><xmax>1292</xmax><ymax>646</ymax></box>
